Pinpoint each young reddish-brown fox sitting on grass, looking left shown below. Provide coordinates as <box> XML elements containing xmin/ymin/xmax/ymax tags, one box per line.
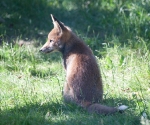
<box><xmin>40</xmin><ymin>14</ymin><xmax>127</xmax><ymax>114</ymax></box>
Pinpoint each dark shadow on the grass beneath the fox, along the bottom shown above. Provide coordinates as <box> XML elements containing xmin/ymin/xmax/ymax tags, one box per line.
<box><xmin>0</xmin><ymin>99</ymin><xmax>140</xmax><ymax>125</ymax></box>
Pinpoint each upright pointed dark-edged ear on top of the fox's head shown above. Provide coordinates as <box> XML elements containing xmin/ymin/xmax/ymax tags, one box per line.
<box><xmin>51</xmin><ymin>14</ymin><xmax>65</xmax><ymax>33</ymax></box>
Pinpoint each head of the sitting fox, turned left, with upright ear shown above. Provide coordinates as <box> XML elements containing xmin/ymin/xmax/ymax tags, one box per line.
<box><xmin>40</xmin><ymin>14</ymin><xmax>71</xmax><ymax>53</ymax></box>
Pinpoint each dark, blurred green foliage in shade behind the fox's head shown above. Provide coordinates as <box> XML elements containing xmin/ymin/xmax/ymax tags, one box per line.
<box><xmin>0</xmin><ymin>0</ymin><xmax>150</xmax><ymax>49</ymax></box>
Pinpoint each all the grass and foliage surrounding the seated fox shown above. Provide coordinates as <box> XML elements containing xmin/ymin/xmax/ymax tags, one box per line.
<box><xmin>0</xmin><ymin>0</ymin><xmax>150</xmax><ymax>125</ymax></box>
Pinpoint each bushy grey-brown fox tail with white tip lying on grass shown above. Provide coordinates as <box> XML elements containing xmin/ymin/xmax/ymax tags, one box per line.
<box><xmin>87</xmin><ymin>103</ymin><xmax>128</xmax><ymax>114</ymax></box>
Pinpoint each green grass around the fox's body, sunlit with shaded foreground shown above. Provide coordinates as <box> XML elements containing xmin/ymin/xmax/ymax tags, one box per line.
<box><xmin>0</xmin><ymin>39</ymin><xmax>150</xmax><ymax>125</ymax></box>
